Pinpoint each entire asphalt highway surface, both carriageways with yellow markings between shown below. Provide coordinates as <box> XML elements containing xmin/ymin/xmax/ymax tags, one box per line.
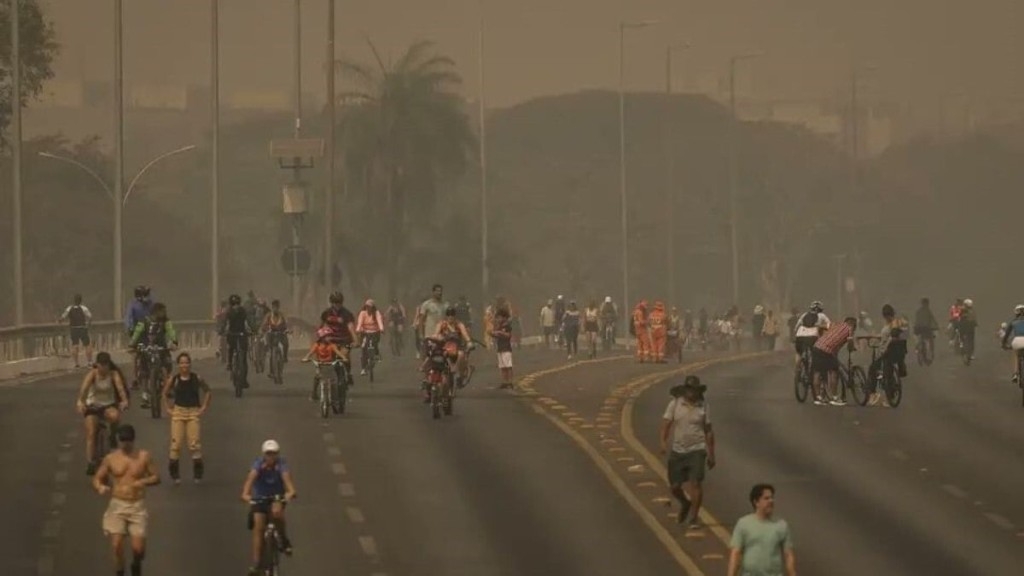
<box><xmin>0</xmin><ymin>338</ymin><xmax>1024</xmax><ymax>576</ymax></box>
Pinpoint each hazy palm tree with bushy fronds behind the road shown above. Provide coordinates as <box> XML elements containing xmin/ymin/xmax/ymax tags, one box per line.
<box><xmin>337</xmin><ymin>41</ymin><xmax>476</xmax><ymax>295</ymax></box>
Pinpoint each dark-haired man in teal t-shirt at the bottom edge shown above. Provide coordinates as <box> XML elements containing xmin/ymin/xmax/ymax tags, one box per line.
<box><xmin>729</xmin><ymin>484</ymin><xmax>797</xmax><ymax>576</ymax></box>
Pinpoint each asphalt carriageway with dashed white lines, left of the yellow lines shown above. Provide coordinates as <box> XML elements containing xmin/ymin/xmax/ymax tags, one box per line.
<box><xmin>0</xmin><ymin>344</ymin><xmax>678</xmax><ymax>576</ymax></box>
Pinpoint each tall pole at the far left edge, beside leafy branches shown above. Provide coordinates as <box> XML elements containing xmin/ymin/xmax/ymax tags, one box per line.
<box><xmin>10</xmin><ymin>0</ymin><xmax>25</xmax><ymax>326</ymax></box>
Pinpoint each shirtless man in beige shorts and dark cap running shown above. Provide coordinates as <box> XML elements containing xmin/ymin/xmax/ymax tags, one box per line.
<box><xmin>92</xmin><ymin>424</ymin><xmax>160</xmax><ymax>576</ymax></box>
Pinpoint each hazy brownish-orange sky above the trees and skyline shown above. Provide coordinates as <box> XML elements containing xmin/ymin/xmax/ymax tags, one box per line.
<box><xmin>41</xmin><ymin>0</ymin><xmax>1024</xmax><ymax>106</ymax></box>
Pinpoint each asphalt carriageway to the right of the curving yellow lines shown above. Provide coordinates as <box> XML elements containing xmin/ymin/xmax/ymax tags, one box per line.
<box><xmin>634</xmin><ymin>342</ymin><xmax>1024</xmax><ymax>576</ymax></box>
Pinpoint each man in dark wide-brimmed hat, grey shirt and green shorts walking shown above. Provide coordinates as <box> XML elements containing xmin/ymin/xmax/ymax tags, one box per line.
<box><xmin>660</xmin><ymin>375</ymin><xmax>715</xmax><ymax>530</ymax></box>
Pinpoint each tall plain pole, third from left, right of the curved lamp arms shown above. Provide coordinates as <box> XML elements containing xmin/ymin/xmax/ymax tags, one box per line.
<box><xmin>210</xmin><ymin>0</ymin><xmax>220</xmax><ymax>314</ymax></box>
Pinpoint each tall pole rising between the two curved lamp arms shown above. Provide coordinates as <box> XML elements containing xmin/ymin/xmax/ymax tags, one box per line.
<box><xmin>111</xmin><ymin>0</ymin><xmax>125</xmax><ymax>320</ymax></box>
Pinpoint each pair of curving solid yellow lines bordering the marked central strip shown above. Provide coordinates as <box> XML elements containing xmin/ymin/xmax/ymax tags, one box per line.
<box><xmin>520</xmin><ymin>353</ymin><xmax>770</xmax><ymax>576</ymax></box>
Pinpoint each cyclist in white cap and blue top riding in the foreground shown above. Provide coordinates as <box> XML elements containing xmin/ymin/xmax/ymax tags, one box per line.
<box><xmin>242</xmin><ymin>440</ymin><xmax>295</xmax><ymax>575</ymax></box>
